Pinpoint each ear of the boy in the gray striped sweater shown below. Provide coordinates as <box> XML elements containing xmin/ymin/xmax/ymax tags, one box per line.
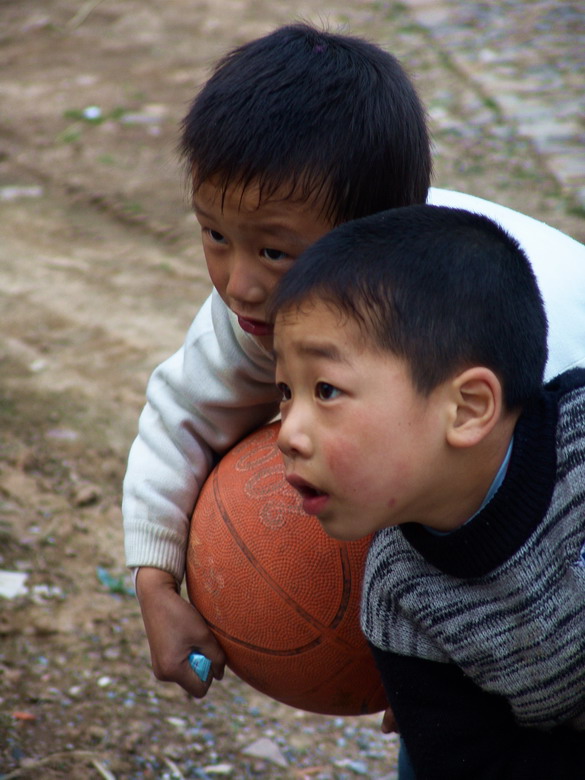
<box><xmin>447</xmin><ymin>366</ymin><xmax>503</xmax><ymax>447</ymax></box>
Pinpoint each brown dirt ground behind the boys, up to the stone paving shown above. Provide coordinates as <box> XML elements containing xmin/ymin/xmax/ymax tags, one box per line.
<box><xmin>0</xmin><ymin>0</ymin><xmax>585</xmax><ymax>780</ymax></box>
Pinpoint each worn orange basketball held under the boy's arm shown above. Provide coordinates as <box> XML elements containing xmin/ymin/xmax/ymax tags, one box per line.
<box><xmin>187</xmin><ymin>423</ymin><xmax>386</xmax><ymax>715</ymax></box>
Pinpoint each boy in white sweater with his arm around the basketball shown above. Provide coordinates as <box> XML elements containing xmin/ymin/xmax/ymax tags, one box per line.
<box><xmin>123</xmin><ymin>25</ymin><xmax>585</xmax><ymax>716</ymax></box>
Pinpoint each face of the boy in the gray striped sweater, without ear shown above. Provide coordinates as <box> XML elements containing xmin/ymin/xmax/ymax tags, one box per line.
<box><xmin>275</xmin><ymin>300</ymin><xmax>450</xmax><ymax>540</ymax></box>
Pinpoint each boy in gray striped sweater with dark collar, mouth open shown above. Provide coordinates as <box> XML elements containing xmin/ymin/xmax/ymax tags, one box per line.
<box><xmin>272</xmin><ymin>206</ymin><xmax>585</xmax><ymax>780</ymax></box>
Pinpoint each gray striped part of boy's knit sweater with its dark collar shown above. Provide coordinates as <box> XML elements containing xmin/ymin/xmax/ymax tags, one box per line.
<box><xmin>362</xmin><ymin>370</ymin><xmax>585</xmax><ymax>729</ymax></box>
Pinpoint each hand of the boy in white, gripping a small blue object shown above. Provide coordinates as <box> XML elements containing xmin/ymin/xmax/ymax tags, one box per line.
<box><xmin>136</xmin><ymin>567</ymin><xmax>225</xmax><ymax>699</ymax></box>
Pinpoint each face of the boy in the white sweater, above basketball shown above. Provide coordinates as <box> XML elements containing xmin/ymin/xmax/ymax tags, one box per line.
<box><xmin>193</xmin><ymin>180</ymin><xmax>333</xmax><ymax>348</ymax></box>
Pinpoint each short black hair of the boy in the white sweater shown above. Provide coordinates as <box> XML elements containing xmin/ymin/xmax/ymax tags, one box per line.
<box><xmin>180</xmin><ymin>23</ymin><xmax>432</xmax><ymax>224</ymax></box>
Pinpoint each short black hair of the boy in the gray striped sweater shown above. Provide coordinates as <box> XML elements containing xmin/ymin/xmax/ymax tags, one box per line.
<box><xmin>270</xmin><ymin>205</ymin><xmax>547</xmax><ymax>410</ymax></box>
